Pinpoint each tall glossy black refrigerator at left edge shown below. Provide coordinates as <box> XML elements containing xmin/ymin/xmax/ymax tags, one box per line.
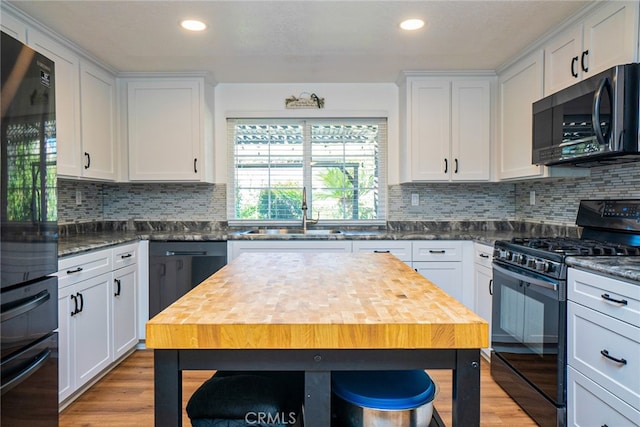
<box><xmin>0</xmin><ymin>33</ymin><xmax>58</xmax><ymax>427</ymax></box>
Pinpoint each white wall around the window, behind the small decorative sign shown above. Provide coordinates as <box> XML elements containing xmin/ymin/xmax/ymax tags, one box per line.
<box><xmin>214</xmin><ymin>83</ymin><xmax>399</xmax><ymax>184</ymax></box>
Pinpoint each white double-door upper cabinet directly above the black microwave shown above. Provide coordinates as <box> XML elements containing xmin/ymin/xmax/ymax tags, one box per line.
<box><xmin>544</xmin><ymin>1</ymin><xmax>638</xmax><ymax>96</ymax></box>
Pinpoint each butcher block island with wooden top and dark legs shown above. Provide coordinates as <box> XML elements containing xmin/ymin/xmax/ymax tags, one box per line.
<box><xmin>146</xmin><ymin>253</ymin><xmax>489</xmax><ymax>427</ymax></box>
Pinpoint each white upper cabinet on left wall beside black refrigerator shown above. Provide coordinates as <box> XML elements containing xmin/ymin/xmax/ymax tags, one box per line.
<box><xmin>28</xmin><ymin>30</ymin><xmax>116</xmax><ymax>181</ymax></box>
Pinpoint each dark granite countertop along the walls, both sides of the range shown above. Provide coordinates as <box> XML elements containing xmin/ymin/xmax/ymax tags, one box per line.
<box><xmin>58</xmin><ymin>222</ymin><xmax>640</xmax><ymax>282</ymax></box>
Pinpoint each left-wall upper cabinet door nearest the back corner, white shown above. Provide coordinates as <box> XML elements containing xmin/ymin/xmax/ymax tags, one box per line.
<box><xmin>80</xmin><ymin>62</ymin><xmax>116</xmax><ymax>180</ymax></box>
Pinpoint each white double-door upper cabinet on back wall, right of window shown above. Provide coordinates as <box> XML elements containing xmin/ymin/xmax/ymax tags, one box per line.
<box><xmin>400</xmin><ymin>76</ymin><xmax>492</xmax><ymax>182</ymax></box>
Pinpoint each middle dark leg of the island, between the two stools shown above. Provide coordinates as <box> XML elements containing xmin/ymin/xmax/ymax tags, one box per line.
<box><xmin>304</xmin><ymin>371</ymin><xmax>331</xmax><ymax>427</ymax></box>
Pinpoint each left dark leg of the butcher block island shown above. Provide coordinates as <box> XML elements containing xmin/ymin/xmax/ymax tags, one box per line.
<box><xmin>153</xmin><ymin>350</ymin><xmax>182</xmax><ymax>427</ymax></box>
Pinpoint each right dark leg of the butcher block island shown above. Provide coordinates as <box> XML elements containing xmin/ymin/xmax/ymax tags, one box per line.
<box><xmin>452</xmin><ymin>350</ymin><xmax>480</xmax><ymax>427</ymax></box>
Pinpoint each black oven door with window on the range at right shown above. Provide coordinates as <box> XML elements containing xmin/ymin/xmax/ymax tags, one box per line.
<box><xmin>491</xmin><ymin>262</ymin><xmax>566</xmax><ymax>404</ymax></box>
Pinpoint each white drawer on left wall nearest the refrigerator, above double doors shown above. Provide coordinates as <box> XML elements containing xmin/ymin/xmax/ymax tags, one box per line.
<box><xmin>56</xmin><ymin>249</ymin><xmax>113</xmax><ymax>288</ymax></box>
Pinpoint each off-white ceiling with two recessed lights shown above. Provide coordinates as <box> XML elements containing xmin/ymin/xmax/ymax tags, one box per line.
<box><xmin>8</xmin><ymin>0</ymin><xmax>593</xmax><ymax>83</ymax></box>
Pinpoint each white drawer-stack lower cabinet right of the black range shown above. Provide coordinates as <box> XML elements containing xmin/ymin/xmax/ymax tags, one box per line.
<box><xmin>567</xmin><ymin>268</ymin><xmax>640</xmax><ymax>426</ymax></box>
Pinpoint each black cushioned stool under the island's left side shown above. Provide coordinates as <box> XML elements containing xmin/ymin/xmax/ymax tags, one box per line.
<box><xmin>187</xmin><ymin>371</ymin><xmax>304</xmax><ymax>427</ymax></box>
